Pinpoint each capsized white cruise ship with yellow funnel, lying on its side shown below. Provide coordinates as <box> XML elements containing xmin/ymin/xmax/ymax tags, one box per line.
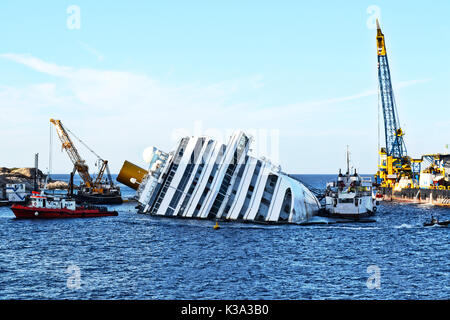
<box><xmin>117</xmin><ymin>131</ymin><xmax>320</xmax><ymax>224</ymax></box>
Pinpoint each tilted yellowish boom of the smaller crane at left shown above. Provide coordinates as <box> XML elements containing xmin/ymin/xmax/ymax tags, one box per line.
<box><xmin>50</xmin><ymin>119</ymin><xmax>93</xmax><ymax>188</ymax></box>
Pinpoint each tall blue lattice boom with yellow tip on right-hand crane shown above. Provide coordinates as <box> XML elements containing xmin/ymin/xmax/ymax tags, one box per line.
<box><xmin>377</xmin><ymin>20</ymin><xmax>407</xmax><ymax>158</ymax></box>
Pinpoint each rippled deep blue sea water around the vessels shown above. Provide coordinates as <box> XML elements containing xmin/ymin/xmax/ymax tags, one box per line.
<box><xmin>0</xmin><ymin>175</ymin><xmax>450</xmax><ymax>299</ymax></box>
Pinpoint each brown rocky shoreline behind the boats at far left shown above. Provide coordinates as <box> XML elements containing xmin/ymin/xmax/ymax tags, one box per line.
<box><xmin>0</xmin><ymin>167</ymin><xmax>69</xmax><ymax>191</ymax></box>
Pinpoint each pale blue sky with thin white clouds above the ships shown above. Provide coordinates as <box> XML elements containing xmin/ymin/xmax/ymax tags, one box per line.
<box><xmin>0</xmin><ymin>0</ymin><xmax>450</xmax><ymax>173</ymax></box>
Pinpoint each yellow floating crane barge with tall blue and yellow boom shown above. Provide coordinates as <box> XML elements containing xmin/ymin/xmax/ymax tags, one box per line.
<box><xmin>375</xmin><ymin>20</ymin><xmax>450</xmax><ymax>206</ymax></box>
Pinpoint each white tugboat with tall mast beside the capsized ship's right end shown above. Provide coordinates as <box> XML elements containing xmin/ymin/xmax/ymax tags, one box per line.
<box><xmin>325</xmin><ymin>149</ymin><xmax>377</xmax><ymax>219</ymax></box>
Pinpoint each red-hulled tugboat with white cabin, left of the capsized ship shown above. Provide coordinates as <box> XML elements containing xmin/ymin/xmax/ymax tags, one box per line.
<box><xmin>11</xmin><ymin>191</ymin><xmax>118</xmax><ymax>219</ymax></box>
